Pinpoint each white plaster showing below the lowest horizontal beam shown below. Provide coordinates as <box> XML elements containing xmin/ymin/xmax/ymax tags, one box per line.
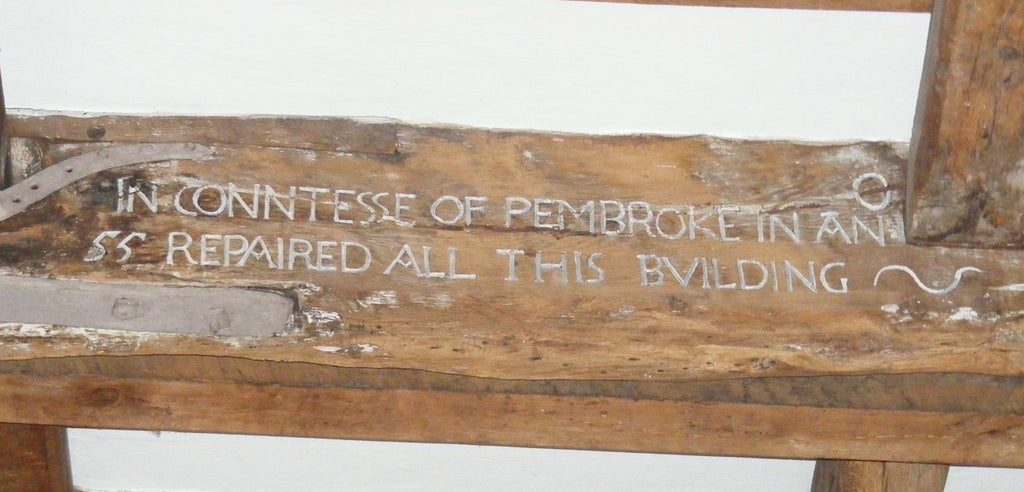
<box><xmin>61</xmin><ymin>429</ymin><xmax>1024</xmax><ymax>492</ymax></box>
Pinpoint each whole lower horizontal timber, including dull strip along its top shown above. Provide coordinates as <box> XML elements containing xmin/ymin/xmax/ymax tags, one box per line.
<box><xmin>0</xmin><ymin>356</ymin><xmax>1024</xmax><ymax>465</ymax></box>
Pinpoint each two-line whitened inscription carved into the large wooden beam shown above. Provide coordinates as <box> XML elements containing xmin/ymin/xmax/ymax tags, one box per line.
<box><xmin>94</xmin><ymin>172</ymin><xmax>983</xmax><ymax>295</ymax></box>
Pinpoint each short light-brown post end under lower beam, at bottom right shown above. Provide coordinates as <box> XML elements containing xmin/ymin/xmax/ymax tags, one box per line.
<box><xmin>811</xmin><ymin>459</ymin><xmax>949</xmax><ymax>492</ymax></box>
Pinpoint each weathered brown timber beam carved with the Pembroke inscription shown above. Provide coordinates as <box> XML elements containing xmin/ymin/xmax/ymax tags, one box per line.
<box><xmin>6</xmin><ymin>117</ymin><xmax>1024</xmax><ymax>381</ymax></box>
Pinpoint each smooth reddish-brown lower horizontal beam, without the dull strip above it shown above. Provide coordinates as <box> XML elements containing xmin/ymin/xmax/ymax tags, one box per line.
<box><xmin>6</xmin><ymin>375</ymin><xmax>1024</xmax><ymax>466</ymax></box>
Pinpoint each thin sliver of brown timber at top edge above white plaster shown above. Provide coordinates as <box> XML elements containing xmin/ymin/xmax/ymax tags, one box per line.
<box><xmin>573</xmin><ymin>0</ymin><xmax>932</xmax><ymax>12</ymax></box>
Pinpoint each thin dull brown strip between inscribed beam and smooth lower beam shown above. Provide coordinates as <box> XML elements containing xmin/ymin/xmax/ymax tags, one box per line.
<box><xmin>6</xmin><ymin>356</ymin><xmax>1024</xmax><ymax>415</ymax></box>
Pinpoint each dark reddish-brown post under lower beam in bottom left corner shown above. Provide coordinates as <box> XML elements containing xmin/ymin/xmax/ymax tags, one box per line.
<box><xmin>0</xmin><ymin>423</ymin><xmax>72</xmax><ymax>492</ymax></box>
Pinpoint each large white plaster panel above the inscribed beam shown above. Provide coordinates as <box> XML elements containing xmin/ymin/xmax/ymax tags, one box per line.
<box><xmin>0</xmin><ymin>0</ymin><xmax>927</xmax><ymax>139</ymax></box>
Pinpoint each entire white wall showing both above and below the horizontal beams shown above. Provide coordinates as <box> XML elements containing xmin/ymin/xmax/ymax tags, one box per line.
<box><xmin>0</xmin><ymin>0</ymin><xmax>1024</xmax><ymax>492</ymax></box>
